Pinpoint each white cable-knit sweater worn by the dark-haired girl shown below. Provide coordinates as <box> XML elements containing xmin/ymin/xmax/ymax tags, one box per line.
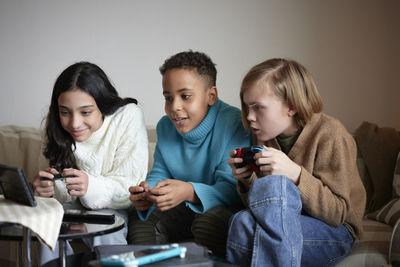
<box><xmin>54</xmin><ymin>104</ymin><xmax>148</xmax><ymax>209</ymax></box>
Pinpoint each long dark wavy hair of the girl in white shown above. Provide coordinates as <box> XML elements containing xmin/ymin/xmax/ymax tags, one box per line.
<box><xmin>43</xmin><ymin>62</ymin><xmax>137</xmax><ymax>171</ymax></box>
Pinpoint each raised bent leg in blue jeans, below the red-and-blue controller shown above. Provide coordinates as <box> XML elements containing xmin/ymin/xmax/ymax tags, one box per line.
<box><xmin>244</xmin><ymin>175</ymin><xmax>303</xmax><ymax>266</ymax></box>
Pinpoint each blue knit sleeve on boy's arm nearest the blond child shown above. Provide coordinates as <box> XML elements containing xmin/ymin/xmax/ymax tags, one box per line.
<box><xmin>186</xmin><ymin>125</ymin><xmax>250</xmax><ymax>213</ymax></box>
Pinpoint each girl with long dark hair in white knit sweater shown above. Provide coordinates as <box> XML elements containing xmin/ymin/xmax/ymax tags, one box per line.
<box><xmin>33</xmin><ymin>62</ymin><xmax>148</xmax><ymax>263</ymax></box>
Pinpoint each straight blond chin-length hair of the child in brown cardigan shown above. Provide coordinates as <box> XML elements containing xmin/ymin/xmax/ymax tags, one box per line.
<box><xmin>240</xmin><ymin>58</ymin><xmax>322</xmax><ymax>129</ymax></box>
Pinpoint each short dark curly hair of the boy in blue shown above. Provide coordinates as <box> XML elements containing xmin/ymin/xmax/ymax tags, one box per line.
<box><xmin>160</xmin><ymin>50</ymin><xmax>217</xmax><ymax>87</ymax></box>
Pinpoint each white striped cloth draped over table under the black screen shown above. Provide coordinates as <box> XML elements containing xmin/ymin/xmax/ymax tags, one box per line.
<box><xmin>0</xmin><ymin>195</ymin><xmax>64</xmax><ymax>250</ymax></box>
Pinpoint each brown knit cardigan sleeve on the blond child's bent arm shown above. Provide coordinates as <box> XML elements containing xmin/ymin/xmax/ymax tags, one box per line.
<box><xmin>298</xmin><ymin>127</ymin><xmax>362</xmax><ymax>226</ymax></box>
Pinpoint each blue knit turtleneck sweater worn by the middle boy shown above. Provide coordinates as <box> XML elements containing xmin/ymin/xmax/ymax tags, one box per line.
<box><xmin>138</xmin><ymin>100</ymin><xmax>250</xmax><ymax>220</ymax></box>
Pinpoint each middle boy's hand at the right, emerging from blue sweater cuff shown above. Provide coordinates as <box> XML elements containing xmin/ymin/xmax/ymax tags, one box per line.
<box><xmin>147</xmin><ymin>179</ymin><xmax>200</xmax><ymax>214</ymax></box>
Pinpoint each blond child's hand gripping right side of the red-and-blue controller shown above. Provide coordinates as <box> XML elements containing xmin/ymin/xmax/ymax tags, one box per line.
<box><xmin>254</xmin><ymin>147</ymin><xmax>301</xmax><ymax>185</ymax></box>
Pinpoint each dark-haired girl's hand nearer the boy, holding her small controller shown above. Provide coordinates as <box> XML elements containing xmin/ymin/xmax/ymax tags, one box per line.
<box><xmin>61</xmin><ymin>168</ymin><xmax>89</xmax><ymax>197</ymax></box>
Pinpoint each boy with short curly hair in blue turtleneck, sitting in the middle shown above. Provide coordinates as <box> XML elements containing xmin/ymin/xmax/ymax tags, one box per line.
<box><xmin>129</xmin><ymin>51</ymin><xmax>250</xmax><ymax>257</ymax></box>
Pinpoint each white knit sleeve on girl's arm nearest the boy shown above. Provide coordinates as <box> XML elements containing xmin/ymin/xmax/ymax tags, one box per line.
<box><xmin>80</xmin><ymin>105</ymin><xmax>148</xmax><ymax>209</ymax></box>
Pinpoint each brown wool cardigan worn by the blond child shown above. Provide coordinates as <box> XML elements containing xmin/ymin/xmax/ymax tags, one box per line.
<box><xmin>239</xmin><ymin>113</ymin><xmax>366</xmax><ymax>238</ymax></box>
